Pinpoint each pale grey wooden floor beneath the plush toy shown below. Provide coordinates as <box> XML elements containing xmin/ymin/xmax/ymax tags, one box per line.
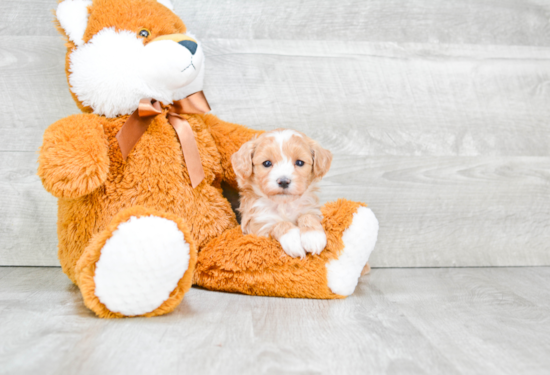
<box><xmin>0</xmin><ymin>267</ymin><xmax>550</xmax><ymax>375</ymax></box>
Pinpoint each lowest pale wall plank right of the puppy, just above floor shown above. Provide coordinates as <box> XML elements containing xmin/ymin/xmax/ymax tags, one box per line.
<box><xmin>322</xmin><ymin>156</ymin><xmax>550</xmax><ymax>267</ymax></box>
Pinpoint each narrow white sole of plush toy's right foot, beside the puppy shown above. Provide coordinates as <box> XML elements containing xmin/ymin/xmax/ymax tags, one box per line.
<box><xmin>326</xmin><ymin>207</ymin><xmax>378</xmax><ymax>296</ymax></box>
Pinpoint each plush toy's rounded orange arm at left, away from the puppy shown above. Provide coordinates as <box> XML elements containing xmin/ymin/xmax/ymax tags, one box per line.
<box><xmin>38</xmin><ymin>114</ymin><xmax>109</xmax><ymax>198</ymax></box>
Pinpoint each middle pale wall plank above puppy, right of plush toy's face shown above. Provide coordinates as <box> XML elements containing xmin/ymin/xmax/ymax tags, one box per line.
<box><xmin>205</xmin><ymin>39</ymin><xmax>550</xmax><ymax>156</ymax></box>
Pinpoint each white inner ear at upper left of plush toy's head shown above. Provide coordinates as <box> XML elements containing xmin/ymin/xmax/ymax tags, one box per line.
<box><xmin>55</xmin><ymin>0</ymin><xmax>92</xmax><ymax>46</ymax></box>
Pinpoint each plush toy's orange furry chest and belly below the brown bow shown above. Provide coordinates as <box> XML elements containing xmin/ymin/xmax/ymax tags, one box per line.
<box><xmin>104</xmin><ymin>116</ymin><xmax>236</xmax><ymax>247</ymax></box>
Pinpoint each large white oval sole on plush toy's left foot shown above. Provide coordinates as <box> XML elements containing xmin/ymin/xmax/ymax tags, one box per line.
<box><xmin>94</xmin><ymin>216</ymin><xmax>190</xmax><ymax>316</ymax></box>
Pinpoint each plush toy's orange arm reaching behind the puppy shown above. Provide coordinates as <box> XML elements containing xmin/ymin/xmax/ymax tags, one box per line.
<box><xmin>203</xmin><ymin>115</ymin><xmax>264</xmax><ymax>189</ymax></box>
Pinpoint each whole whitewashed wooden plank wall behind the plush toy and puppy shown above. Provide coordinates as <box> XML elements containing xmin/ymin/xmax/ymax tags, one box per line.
<box><xmin>0</xmin><ymin>0</ymin><xmax>550</xmax><ymax>267</ymax></box>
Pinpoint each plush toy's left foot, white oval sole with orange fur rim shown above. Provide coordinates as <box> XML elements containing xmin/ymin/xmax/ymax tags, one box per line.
<box><xmin>75</xmin><ymin>207</ymin><xmax>196</xmax><ymax>318</ymax></box>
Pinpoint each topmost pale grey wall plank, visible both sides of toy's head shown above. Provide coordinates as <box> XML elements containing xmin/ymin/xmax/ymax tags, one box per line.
<box><xmin>0</xmin><ymin>0</ymin><xmax>550</xmax><ymax>46</ymax></box>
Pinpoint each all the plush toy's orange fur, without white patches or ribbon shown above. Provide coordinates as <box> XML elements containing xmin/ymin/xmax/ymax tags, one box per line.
<box><xmin>38</xmin><ymin>0</ymin><xmax>374</xmax><ymax>318</ymax></box>
